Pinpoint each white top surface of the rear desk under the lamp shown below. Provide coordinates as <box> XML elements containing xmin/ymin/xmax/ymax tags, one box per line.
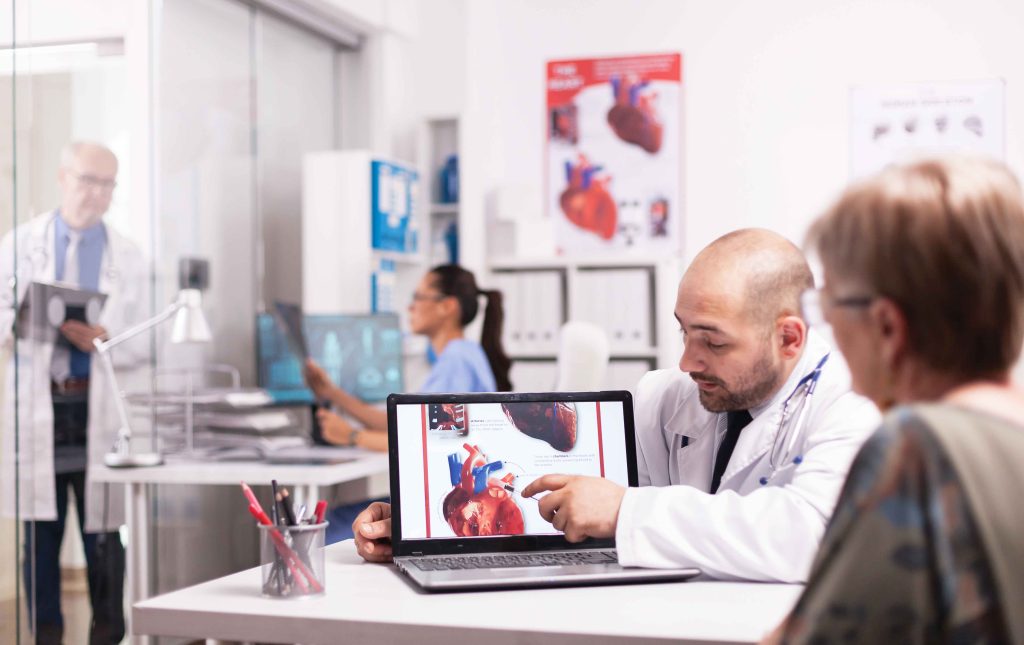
<box><xmin>89</xmin><ymin>450</ymin><xmax>388</xmax><ymax>486</ymax></box>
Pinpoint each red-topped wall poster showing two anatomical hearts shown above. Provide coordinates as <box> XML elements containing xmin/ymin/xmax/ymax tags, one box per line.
<box><xmin>545</xmin><ymin>53</ymin><xmax>682</xmax><ymax>255</ymax></box>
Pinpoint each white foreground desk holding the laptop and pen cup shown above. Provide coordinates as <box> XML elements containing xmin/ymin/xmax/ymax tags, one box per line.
<box><xmin>132</xmin><ymin>541</ymin><xmax>802</xmax><ymax>645</ymax></box>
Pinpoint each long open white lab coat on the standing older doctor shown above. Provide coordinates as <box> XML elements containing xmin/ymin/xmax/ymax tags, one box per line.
<box><xmin>0</xmin><ymin>212</ymin><xmax>150</xmax><ymax>532</ymax></box>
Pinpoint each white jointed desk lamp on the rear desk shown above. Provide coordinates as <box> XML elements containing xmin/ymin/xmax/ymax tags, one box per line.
<box><xmin>92</xmin><ymin>258</ymin><xmax>211</xmax><ymax>468</ymax></box>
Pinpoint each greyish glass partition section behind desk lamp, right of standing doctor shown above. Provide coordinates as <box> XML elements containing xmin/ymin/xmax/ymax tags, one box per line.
<box><xmin>153</xmin><ymin>0</ymin><xmax>337</xmax><ymax>602</ymax></box>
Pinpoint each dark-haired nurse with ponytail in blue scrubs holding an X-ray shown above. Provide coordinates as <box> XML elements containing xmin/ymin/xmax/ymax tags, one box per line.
<box><xmin>305</xmin><ymin>264</ymin><xmax>512</xmax><ymax>544</ymax></box>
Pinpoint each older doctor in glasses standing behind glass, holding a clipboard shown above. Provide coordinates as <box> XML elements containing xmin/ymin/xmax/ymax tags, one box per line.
<box><xmin>0</xmin><ymin>142</ymin><xmax>147</xmax><ymax>643</ymax></box>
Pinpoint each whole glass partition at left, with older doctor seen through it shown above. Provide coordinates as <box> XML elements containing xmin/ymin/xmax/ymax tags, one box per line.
<box><xmin>0</xmin><ymin>0</ymin><xmax>348</xmax><ymax>643</ymax></box>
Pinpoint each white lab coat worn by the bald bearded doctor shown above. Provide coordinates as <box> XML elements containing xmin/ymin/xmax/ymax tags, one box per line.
<box><xmin>615</xmin><ymin>332</ymin><xmax>881</xmax><ymax>583</ymax></box>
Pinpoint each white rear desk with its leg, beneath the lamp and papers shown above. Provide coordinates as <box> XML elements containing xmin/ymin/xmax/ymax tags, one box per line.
<box><xmin>89</xmin><ymin>450</ymin><xmax>388</xmax><ymax>642</ymax></box>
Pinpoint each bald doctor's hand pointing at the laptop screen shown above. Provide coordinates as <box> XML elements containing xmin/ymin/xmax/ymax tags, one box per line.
<box><xmin>522</xmin><ymin>475</ymin><xmax>626</xmax><ymax>542</ymax></box>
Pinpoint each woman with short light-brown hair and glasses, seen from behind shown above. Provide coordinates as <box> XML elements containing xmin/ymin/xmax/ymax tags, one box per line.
<box><xmin>772</xmin><ymin>159</ymin><xmax>1024</xmax><ymax>643</ymax></box>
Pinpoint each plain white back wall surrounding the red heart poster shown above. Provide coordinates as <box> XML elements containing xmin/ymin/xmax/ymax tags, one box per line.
<box><xmin>460</xmin><ymin>0</ymin><xmax>1024</xmax><ymax>267</ymax></box>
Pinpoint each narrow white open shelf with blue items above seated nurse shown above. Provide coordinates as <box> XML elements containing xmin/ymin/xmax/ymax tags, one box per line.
<box><xmin>418</xmin><ymin>115</ymin><xmax>461</xmax><ymax>266</ymax></box>
